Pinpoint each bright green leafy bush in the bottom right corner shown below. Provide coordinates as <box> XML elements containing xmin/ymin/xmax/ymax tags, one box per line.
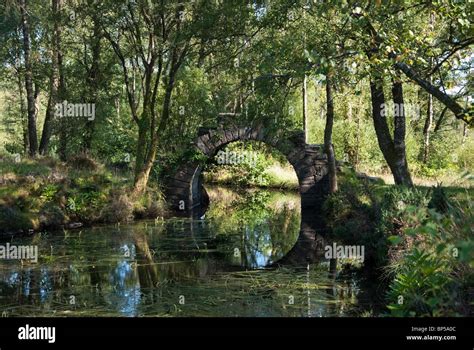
<box><xmin>388</xmin><ymin>200</ymin><xmax>474</xmax><ymax>316</ymax></box>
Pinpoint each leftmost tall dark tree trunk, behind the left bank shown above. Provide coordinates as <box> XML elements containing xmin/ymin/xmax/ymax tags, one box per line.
<box><xmin>19</xmin><ymin>0</ymin><xmax>38</xmax><ymax>157</ymax></box>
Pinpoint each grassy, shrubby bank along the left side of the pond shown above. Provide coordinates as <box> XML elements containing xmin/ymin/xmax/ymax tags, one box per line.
<box><xmin>0</xmin><ymin>156</ymin><xmax>164</xmax><ymax>234</ymax></box>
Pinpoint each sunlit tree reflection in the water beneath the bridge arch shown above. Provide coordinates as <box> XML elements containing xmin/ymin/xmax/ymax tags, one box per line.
<box><xmin>206</xmin><ymin>188</ymin><xmax>300</xmax><ymax>268</ymax></box>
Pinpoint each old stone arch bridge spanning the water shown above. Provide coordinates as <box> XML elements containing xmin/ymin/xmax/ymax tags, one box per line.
<box><xmin>165</xmin><ymin>117</ymin><xmax>329</xmax><ymax>211</ymax></box>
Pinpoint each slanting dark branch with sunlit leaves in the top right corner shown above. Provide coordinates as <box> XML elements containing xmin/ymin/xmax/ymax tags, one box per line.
<box><xmin>353</xmin><ymin>2</ymin><xmax>474</xmax><ymax>125</ymax></box>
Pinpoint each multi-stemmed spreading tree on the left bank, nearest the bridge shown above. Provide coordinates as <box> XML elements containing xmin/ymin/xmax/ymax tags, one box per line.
<box><xmin>103</xmin><ymin>1</ymin><xmax>256</xmax><ymax>193</ymax></box>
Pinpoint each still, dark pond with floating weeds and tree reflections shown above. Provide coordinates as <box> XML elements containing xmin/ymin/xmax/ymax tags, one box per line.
<box><xmin>0</xmin><ymin>186</ymin><xmax>376</xmax><ymax>317</ymax></box>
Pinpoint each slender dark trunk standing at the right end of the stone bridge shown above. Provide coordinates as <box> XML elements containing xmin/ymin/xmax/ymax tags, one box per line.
<box><xmin>324</xmin><ymin>75</ymin><xmax>337</xmax><ymax>193</ymax></box>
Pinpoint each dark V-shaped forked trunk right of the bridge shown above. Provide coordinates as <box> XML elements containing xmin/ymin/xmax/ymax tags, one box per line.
<box><xmin>370</xmin><ymin>77</ymin><xmax>413</xmax><ymax>186</ymax></box>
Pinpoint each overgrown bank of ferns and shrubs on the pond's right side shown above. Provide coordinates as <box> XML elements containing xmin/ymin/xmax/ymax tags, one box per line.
<box><xmin>325</xmin><ymin>172</ymin><xmax>474</xmax><ymax>316</ymax></box>
